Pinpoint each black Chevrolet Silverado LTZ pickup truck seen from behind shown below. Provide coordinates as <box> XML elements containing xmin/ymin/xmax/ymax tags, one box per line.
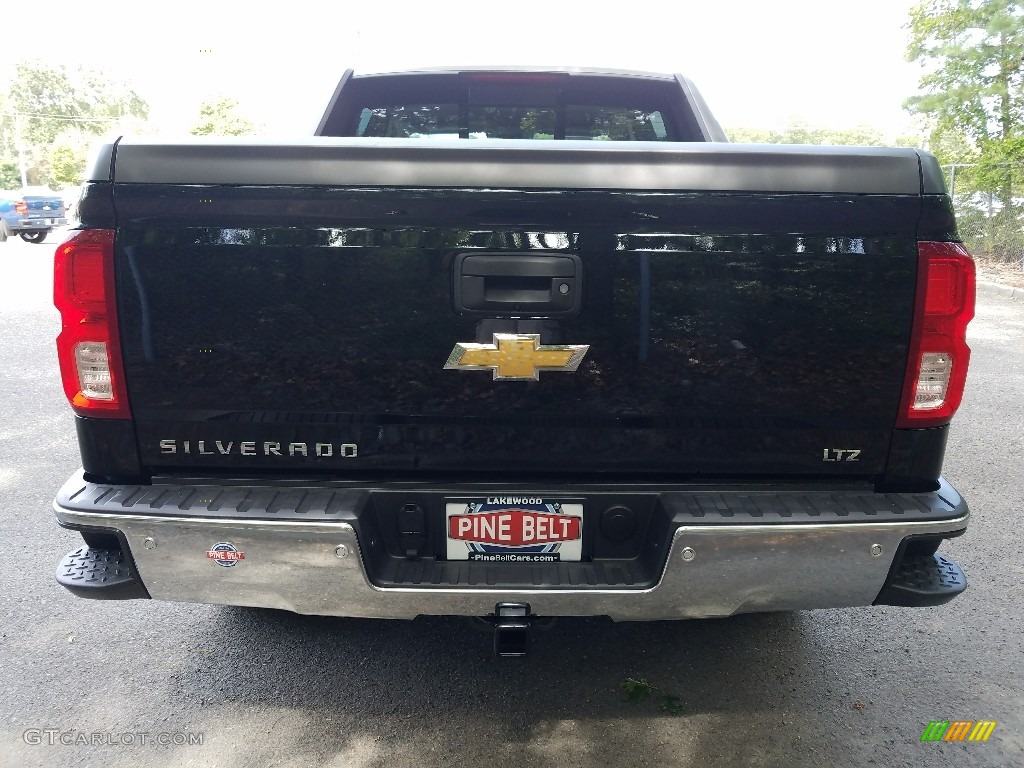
<box><xmin>54</xmin><ymin>70</ymin><xmax>974</xmax><ymax>654</ymax></box>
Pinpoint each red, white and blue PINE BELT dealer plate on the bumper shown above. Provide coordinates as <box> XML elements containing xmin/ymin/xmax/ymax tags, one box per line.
<box><xmin>444</xmin><ymin>496</ymin><xmax>583</xmax><ymax>563</ymax></box>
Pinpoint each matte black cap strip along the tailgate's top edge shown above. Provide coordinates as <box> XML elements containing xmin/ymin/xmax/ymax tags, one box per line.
<box><xmin>113</xmin><ymin>138</ymin><xmax>922</xmax><ymax>195</ymax></box>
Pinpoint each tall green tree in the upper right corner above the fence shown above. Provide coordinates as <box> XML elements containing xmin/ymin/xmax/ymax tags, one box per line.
<box><xmin>904</xmin><ymin>0</ymin><xmax>1024</xmax><ymax>211</ymax></box>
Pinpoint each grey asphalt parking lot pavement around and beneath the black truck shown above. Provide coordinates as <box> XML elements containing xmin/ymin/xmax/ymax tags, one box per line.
<box><xmin>0</xmin><ymin>236</ymin><xmax>1024</xmax><ymax>768</ymax></box>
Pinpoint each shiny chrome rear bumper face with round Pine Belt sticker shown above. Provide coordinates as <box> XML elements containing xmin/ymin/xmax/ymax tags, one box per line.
<box><xmin>54</xmin><ymin>502</ymin><xmax>969</xmax><ymax>621</ymax></box>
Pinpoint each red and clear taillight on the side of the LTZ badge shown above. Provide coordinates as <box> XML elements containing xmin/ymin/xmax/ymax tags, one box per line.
<box><xmin>896</xmin><ymin>243</ymin><xmax>975</xmax><ymax>428</ymax></box>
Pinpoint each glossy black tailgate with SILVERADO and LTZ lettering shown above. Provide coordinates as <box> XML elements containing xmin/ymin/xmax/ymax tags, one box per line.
<box><xmin>113</xmin><ymin>140</ymin><xmax>922</xmax><ymax>478</ymax></box>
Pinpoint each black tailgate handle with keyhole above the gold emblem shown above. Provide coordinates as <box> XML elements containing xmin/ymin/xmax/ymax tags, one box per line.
<box><xmin>453</xmin><ymin>253</ymin><xmax>583</xmax><ymax>317</ymax></box>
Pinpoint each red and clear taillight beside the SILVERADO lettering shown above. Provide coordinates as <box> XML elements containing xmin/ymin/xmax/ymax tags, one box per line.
<box><xmin>53</xmin><ymin>229</ymin><xmax>131</xmax><ymax>419</ymax></box>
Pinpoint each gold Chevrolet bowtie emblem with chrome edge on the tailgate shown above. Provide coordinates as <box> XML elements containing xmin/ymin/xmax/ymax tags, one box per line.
<box><xmin>444</xmin><ymin>334</ymin><xmax>590</xmax><ymax>381</ymax></box>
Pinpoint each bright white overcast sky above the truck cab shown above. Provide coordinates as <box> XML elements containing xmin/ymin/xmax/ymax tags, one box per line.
<box><xmin>0</xmin><ymin>0</ymin><xmax>921</xmax><ymax>135</ymax></box>
